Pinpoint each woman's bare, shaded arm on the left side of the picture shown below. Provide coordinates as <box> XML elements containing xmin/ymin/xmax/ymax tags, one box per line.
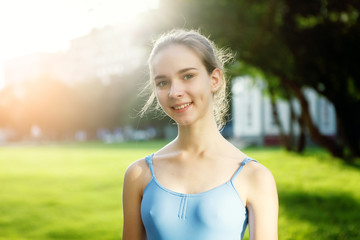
<box><xmin>122</xmin><ymin>160</ymin><xmax>146</xmax><ymax>240</ymax></box>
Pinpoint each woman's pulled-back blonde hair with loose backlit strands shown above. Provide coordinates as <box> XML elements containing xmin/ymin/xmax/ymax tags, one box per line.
<box><xmin>140</xmin><ymin>29</ymin><xmax>233</xmax><ymax>129</ymax></box>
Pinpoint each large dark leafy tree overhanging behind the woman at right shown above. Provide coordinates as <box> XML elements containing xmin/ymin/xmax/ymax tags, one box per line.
<box><xmin>150</xmin><ymin>0</ymin><xmax>360</xmax><ymax>159</ymax></box>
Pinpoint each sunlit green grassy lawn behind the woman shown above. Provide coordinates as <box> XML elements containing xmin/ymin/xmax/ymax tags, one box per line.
<box><xmin>0</xmin><ymin>141</ymin><xmax>360</xmax><ymax>240</ymax></box>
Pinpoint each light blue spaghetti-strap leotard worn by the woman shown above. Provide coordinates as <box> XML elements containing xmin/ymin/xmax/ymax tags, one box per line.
<box><xmin>141</xmin><ymin>155</ymin><xmax>255</xmax><ymax>240</ymax></box>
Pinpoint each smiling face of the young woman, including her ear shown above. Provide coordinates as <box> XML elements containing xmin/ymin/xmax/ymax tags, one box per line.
<box><xmin>152</xmin><ymin>44</ymin><xmax>221</xmax><ymax>125</ymax></box>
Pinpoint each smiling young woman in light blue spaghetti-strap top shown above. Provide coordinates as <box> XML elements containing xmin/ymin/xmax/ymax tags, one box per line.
<box><xmin>123</xmin><ymin>30</ymin><xmax>278</xmax><ymax>240</ymax></box>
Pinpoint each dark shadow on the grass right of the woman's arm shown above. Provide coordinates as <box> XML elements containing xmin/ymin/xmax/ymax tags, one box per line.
<box><xmin>279</xmin><ymin>192</ymin><xmax>360</xmax><ymax>239</ymax></box>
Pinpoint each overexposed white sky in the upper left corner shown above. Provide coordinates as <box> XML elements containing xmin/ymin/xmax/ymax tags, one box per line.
<box><xmin>0</xmin><ymin>0</ymin><xmax>158</xmax><ymax>89</ymax></box>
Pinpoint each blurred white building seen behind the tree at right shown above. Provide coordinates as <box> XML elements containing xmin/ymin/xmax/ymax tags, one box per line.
<box><xmin>232</xmin><ymin>76</ymin><xmax>336</xmax><ymax>145</ymax></box>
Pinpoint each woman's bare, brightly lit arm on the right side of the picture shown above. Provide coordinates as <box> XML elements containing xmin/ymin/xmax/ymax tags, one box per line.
<box><xmin>247</xmin><ymin>164</ymin><xmax>279</xmax><ymax>240</ymax></box>
